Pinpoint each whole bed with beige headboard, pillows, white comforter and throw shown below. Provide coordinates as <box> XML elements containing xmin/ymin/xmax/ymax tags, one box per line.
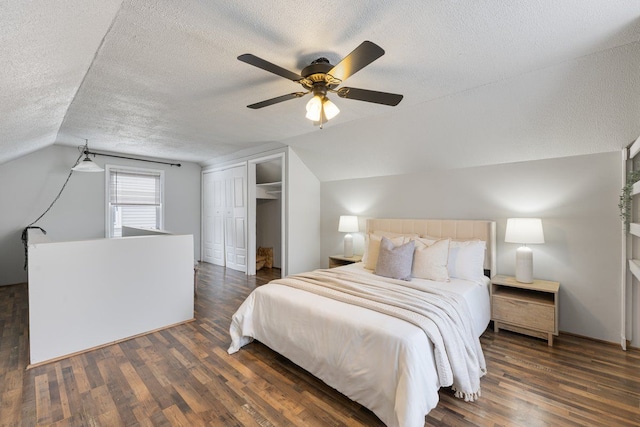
<box><xmin>228</xmin><ymin>219</ymin><xmax>496</xmax><ymax>427</ymax></box>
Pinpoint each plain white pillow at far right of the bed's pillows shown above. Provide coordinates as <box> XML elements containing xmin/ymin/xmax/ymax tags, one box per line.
<box><xmin>447</xmin><ymin>240</ymin><xmax>487</xmax><ymax>282</ymax></box>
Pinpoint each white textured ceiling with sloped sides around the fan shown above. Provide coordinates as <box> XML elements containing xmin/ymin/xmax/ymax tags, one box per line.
<box><xmin>0</xmin><ymin>0</ymin><xmax>640</xmax><ymax>180</ymax></box>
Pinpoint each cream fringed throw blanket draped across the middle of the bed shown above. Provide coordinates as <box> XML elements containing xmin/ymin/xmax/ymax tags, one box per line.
<box><xmin>273</xmin><ymin>270</ymin><xmax>486</xmax><ymax>401</ymax></box>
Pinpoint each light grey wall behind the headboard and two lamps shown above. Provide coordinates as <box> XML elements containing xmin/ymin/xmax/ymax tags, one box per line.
<box><xmin>321</xmin><ymin>152</ymin><xmax>624</xmax><ymax>343</ymax></box>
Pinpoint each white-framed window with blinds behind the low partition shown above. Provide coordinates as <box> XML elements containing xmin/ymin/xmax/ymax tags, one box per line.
<box><xmin>106</xmin><ymin>165</ymin><xmax>164</xmax><ymax>237</ymax></box>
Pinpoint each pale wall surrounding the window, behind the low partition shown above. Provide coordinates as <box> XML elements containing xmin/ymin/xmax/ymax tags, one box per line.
<box><xmin>0</xmin><ymin>145</ymin><xmax>201</xmax><ymax>285</ymax></box>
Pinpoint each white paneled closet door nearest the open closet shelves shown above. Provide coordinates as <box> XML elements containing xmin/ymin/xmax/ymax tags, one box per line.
<box><xmin>224</xmin><ymin>166</ymin><xmax>247</xmax><ymax>272</ymax></box>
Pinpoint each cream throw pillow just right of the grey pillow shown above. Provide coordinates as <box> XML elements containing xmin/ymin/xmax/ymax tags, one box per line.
<box><xmin>411</xmin><ymin>239</ymin><xmax>450</xmax><ymax>282</ymax></box>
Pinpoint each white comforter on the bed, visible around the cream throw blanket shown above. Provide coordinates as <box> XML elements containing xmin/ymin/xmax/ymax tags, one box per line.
<box><xmin>229</xmin><ymin>264</ymin><xmax>490</xmax><ymax>427</ymax></box>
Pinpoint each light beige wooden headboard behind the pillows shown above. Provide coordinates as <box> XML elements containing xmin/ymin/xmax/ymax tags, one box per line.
<box><xmin>367</xmin><ymin>218</ymin><xmax>497</xmax><ymax>276</ymax></box>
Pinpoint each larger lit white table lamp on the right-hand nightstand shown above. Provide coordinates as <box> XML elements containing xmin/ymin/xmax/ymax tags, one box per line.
<box><xmin>504</xmin><ymin>218</ymin><xmax>544</xmax><ymax>283</ymax></box>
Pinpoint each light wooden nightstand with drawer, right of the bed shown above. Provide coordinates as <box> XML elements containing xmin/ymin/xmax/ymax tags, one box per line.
<box><xmin>491</xmin><ymin>275</ymin><xmax>560</xmax><ymax>346</ymax></box>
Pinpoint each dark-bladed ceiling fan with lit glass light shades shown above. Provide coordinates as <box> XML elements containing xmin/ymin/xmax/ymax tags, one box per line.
<box><xmin>238</xmin><ymin>41</ymin><xmax>402</xmax><ymax>127</ymax></box>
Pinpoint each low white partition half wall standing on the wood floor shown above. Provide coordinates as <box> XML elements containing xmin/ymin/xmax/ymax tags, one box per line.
<box><xmin>29</xmin><ymin>235</ymin><xmax>194</xmax><ymax>365</ymax></box>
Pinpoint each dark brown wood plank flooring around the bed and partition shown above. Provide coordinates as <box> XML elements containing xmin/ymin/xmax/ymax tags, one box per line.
<box><xmin>0</xmin><ymin>264</ymin><xmax>640</xmax><ymax>427</ymax></box>
